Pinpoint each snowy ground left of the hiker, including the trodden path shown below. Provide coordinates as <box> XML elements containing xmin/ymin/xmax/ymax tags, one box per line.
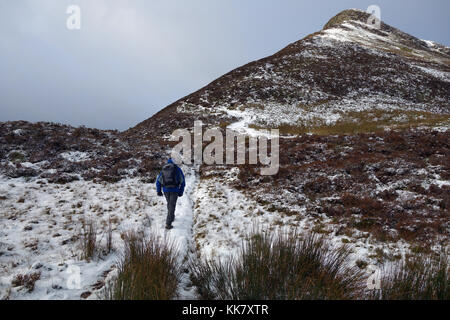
<box><xmin>0</xmin><ymin>165</ymin><xmax>196</xmax><ymax>299</ymax></box>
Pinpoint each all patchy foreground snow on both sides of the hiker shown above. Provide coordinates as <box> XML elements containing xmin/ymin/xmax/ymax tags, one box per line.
<box><xmin>0</xmin><ymin>162</ymin><xmax>440</xmax><ymax>299</ymax></box>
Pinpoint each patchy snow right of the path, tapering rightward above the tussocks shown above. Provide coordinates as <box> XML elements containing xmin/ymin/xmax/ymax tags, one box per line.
<box><xmin>193</xmin><ymin>172</ymin><xmax>409</xmax><ymax>268</ymax></box>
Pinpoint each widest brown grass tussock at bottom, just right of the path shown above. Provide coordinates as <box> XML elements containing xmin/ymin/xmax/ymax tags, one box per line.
<box><xmin>190</xmin><ymin>233</ymin><xmax>364</xmax><ymax>300</ymax></box>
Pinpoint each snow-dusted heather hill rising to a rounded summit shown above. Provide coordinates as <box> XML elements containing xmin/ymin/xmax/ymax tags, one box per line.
<box><xmin>127</xmin><ymin>10</ymin><xmax>450</xmax><ymax>136</ymax></box>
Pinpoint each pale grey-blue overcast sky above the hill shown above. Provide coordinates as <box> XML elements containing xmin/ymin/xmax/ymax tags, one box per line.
<box><xmin>0</xmin><ymin>0</ymin><xmax>450</xmax><ymax>130</ymax></box>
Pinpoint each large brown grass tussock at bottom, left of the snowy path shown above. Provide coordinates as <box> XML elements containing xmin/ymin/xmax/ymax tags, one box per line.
<box><xmin>106</xmin><ymin>233</ymin><xmax>182</xmax><ymax>300</ymax></box>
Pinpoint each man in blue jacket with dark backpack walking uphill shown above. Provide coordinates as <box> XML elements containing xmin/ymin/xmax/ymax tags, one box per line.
<box><xmin>156</xmin><ymin>159</ymin><xmax>186</xmax><ymax>230</ymax></box>
